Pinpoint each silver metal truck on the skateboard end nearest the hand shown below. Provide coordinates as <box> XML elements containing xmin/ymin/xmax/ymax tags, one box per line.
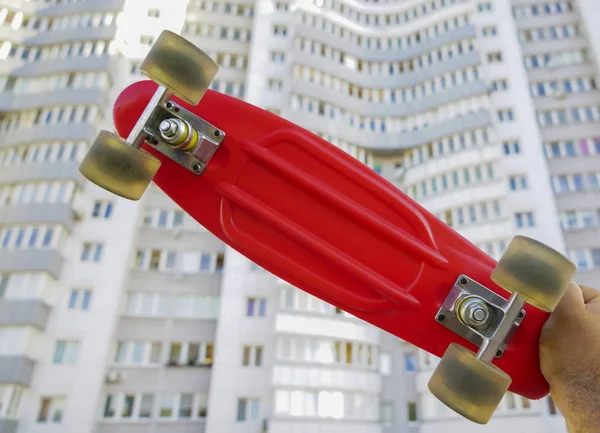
<box><xmin>435</xmin><ymin>275</ymin><xmax>525</xmax><ymax>362</ymax></box>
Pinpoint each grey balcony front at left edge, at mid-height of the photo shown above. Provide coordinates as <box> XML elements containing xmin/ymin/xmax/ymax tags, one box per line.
<box><xmin>0</xmin><ymin>203</ymin><xmax>73</xmax><ymax>230</ymax></box>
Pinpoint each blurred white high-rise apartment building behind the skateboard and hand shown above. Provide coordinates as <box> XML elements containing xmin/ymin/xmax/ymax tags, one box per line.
<box><xmin>0</xmin><ymin>0</ymin><xmax>600</xmax><ymax>433</ymax></box>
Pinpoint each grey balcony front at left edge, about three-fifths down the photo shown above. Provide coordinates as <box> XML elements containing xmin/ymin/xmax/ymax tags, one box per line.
<box><xmin>0</xmin><ymin>250</ymin><xmax>64</xmax><ymax>278</ymax></box>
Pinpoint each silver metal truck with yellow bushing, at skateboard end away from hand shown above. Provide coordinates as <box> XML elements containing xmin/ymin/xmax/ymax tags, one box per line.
<box><xmin>122</xmin><ymin>86</ymin><xmax>225</xmax><ymax>175</ymax></box>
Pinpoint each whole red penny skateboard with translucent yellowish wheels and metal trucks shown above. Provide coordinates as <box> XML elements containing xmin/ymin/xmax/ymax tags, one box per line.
<box><xmin>81</xmin><ymin>31</ymin><xmax>575</xmax><ymax>423</ymax></box>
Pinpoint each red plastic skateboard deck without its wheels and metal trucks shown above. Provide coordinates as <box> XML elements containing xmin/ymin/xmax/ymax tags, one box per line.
<box><xmin>114</xmin><ymin>81</ymin><xmax>548</xmax><ymax>399</ymax></box>
